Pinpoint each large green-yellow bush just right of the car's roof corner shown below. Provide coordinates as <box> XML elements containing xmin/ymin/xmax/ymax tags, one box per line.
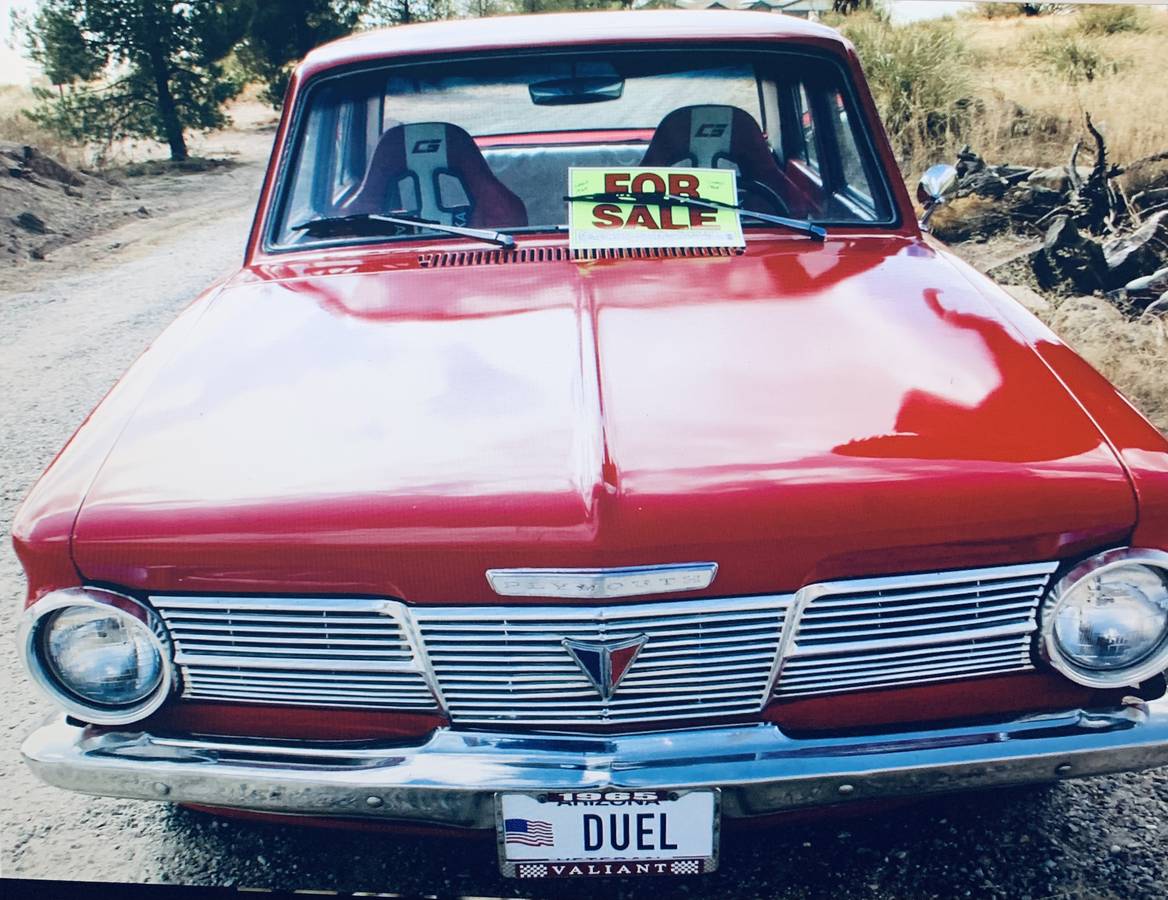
<box><xmin>843</xmin><ymin>20</ymin><xmax>972</xmax><ymax>160</ymax></box>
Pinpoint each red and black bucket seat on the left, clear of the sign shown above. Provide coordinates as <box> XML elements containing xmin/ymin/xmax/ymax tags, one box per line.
<box><xmin>343</xmin><ymin>121</ymin><xmax>527</xmax><ymax>228</ymax></box>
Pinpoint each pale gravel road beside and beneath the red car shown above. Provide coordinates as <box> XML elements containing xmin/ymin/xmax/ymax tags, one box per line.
<box><xmin>0</xmin><ymin>152</ymin><xmax>1168</xmax><ymax>900</ymax></box>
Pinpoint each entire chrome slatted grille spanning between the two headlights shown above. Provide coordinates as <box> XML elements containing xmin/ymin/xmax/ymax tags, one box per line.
<box><xmin>151</xmin><ymin>563</ymin><xmax>1056</xmax><ymax>726</ymax></box>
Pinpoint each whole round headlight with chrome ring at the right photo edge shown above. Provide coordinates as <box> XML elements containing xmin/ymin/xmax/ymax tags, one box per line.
<box><xmin>1043</xmin><ymin>549</ymin><xmax>1168</xmax><ymax>688</ymax></box>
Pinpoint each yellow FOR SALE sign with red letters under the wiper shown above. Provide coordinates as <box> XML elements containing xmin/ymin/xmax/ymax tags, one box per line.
<box><xmin>568</xmin><ymin>167</ymin><xmax>745</xmax><ymax>250</ymax></box>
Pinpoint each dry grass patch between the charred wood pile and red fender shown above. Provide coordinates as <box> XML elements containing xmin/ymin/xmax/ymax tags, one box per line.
<box><xmin>1038</xmin><ymin>296</ymin><xmax>1168</xmax><ymax>434</ymax></box>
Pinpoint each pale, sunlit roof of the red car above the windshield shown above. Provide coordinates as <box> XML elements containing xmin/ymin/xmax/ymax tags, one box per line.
<box><xmin>299</xmin><ymin>9</ymin><xmax>846</xmax><ymax>78</ymax></box>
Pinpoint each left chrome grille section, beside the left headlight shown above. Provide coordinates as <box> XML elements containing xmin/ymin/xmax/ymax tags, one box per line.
<box><xmin>151</xmin><ymin>596</ymin><xmax>437</xmax><ymax>710</ymax></box>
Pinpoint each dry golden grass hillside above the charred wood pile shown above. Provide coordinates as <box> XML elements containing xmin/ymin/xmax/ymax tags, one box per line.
<box><xmin>837</xmin><ymin>7</ymin><xmax>1168</xmax><ymax>187</ymax></box>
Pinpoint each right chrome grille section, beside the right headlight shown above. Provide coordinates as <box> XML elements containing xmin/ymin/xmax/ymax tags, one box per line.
<box><xmin>778</xmin><ymin>563</ymin><xmax>1056</xmax><ymax>696</ymax></box>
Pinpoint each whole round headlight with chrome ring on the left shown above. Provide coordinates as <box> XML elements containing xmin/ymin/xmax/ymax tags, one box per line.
<box><xmin>22</xmin><ymin>588</ymin><xmax>173</xmax><ymax>725</ymax></box>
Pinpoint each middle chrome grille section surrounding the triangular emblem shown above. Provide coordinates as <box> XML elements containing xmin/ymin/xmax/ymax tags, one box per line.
<box><xmin>412</xmin><ymin>596</ymin><xmax>791</xmax><ymax>725</ymax></box>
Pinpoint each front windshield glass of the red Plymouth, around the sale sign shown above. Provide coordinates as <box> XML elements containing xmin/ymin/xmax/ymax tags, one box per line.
<box><xmin>272</xmin><ymin>49</ymin><xmax>894</xmax><ymax>246</ymax></box>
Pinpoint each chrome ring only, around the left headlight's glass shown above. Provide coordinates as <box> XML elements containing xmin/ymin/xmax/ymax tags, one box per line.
<box><xmin>18</xmin><ymin>587</ymin><xmax>176</xmax><ymax>725</ymax></box>
